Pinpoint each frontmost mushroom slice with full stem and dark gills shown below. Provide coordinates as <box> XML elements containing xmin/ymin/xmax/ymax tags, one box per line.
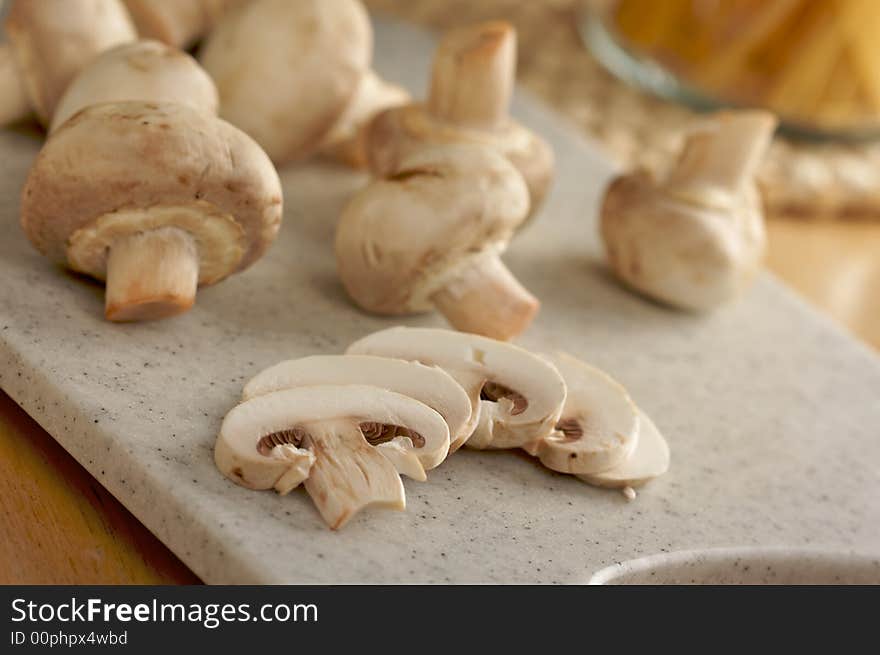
<box><xmin>214</xmin><ymin>385</ymin><xmax>449</xmax><ymax>529</ymax></box>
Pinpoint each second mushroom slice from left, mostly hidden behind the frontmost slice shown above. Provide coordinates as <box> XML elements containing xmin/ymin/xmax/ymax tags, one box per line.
<box><xmin>237</xmin><ymin>355</ymin><xmax>471</xmax><ymax>469</ymax></box>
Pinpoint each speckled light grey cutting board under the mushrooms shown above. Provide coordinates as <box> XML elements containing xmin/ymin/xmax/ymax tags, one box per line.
<box><xmin>0</xmin><ymin>16</ymin><xmax>880</xmax><ymax>583</ymax></box>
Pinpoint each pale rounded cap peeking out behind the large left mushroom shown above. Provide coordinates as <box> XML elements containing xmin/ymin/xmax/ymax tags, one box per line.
<box><xmin>49</xmin><ymin>40</ymin><xmax>220</xmax><ymax>133</ymax></box>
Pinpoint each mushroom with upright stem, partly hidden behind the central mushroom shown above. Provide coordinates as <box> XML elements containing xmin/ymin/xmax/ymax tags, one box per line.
<box><xmin>365</xmin><ymin>21</ymin><xmax>554</xmax><ymax>218</ymax></box>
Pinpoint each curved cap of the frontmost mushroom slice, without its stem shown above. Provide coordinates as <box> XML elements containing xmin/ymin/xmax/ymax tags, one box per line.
<box><xmin>214</xmin><ymin>384</ymin><xmax>449</xmax><ymax>489</ymax></box>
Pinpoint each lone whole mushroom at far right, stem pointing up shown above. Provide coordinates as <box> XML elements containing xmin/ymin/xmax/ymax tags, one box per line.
<box><xmin>601</xmin><ymin>111</ymin><xmax>776</xmax><ymax>310</ymax></box>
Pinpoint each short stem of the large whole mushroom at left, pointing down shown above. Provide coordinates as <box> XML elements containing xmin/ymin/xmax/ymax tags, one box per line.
<box><xmin>105</xmin><ymin>227</ymin><xmax>199</xmax><ymax>321</ymax></box>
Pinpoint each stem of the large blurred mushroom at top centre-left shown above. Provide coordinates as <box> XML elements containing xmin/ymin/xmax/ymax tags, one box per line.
<box><xmin>321</xmin><ymin>70</ymin><xmax>410</xmax><ymax>168</ymax></box>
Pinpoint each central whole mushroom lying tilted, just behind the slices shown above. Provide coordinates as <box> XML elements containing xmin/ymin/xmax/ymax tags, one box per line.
<box><xmin>336</xmin><ymin>144</ymin><xmax>539</xmax><ymax>339</ymax></box>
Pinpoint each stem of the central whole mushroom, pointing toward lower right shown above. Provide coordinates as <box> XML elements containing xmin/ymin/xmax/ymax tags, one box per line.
<box><xmin>431</xmin><ymin>255</ymin><xmax>540</xmax><ymax>341</ymax></box>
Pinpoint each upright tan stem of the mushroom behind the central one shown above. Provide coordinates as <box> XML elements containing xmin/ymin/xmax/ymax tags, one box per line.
<box><xmin>428</xmin><ymin>21</ymin><xmax>516</xmax><ymax>128</ymax></box>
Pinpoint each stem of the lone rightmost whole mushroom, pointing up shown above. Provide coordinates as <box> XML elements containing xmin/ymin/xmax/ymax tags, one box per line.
<box><xmin>665</xmin><ymin>110</ymin><xmax>777</xmax><ymax>197</ymax></box>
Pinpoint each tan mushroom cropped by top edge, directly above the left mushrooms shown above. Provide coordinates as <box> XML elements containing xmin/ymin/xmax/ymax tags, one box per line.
<box><xmin>124</xmin><ymin>0</ymin><xmax>250</xmax><ymax>49</ymax></box>
